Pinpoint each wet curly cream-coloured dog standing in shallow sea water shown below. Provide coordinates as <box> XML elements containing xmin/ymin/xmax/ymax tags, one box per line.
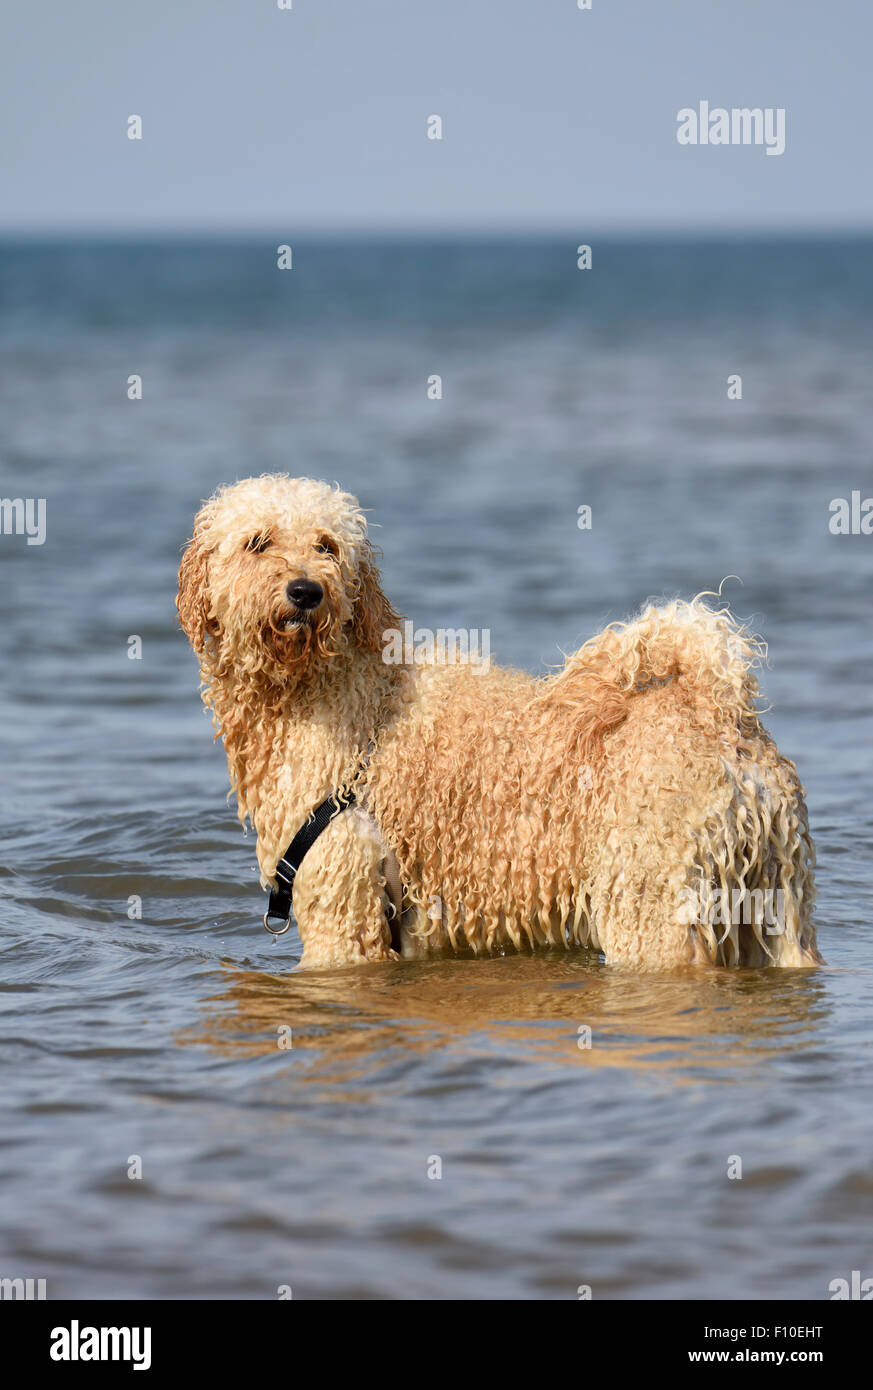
<box><xmin>177</xmin><ymin>474</ymin><xmax>822</xmax><ymax>970</ymax></box>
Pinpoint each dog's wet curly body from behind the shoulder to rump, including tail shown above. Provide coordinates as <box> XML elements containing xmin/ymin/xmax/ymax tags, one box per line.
<box><xmin>371</xmin><ymin>602</ymin><xmax>820</xmax><ymax>966</ymax></box>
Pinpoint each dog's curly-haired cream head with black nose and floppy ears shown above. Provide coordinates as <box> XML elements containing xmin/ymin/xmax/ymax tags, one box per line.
<box><xmin>177</xmin><ymin>474</ymin><xmax>399</xmax><ymax>682</ymax></box>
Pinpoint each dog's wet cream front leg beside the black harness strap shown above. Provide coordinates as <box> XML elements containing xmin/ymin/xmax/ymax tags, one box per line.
<box><xmin>284</xmin><ymin>808</ymin><xmax>398</xmax><ymax>969</ymax></box>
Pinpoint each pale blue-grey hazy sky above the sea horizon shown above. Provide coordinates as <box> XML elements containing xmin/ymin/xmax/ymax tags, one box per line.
<box><xmin>0</xmin><ymin>0</ymin><xmax>873</xmax><ymax>239</ymax></box>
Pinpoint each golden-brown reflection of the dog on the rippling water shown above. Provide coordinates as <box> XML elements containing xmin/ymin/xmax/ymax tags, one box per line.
<box><xmin>186</xmin><ymin>952</ymin><xmax>827</xmax><ymax>1083</ymax></box>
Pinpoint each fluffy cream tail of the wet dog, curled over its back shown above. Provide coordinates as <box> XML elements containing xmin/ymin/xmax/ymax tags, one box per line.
<box><xmin>537</xmin><ymin>595</ymin><xmax>766</xmax><ymax>744</ymax></box>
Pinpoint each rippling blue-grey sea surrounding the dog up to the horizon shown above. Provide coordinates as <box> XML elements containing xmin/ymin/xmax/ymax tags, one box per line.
<box><xmin>0</xmin><ymin>236</ymin><xmax>873</xmax><ymax>1301</ymax></box>
